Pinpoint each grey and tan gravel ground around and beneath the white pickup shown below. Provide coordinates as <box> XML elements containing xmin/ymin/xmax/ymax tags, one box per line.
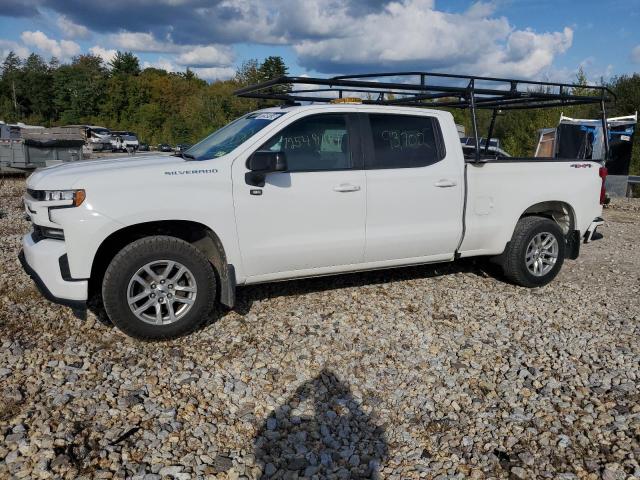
<box><xmin>0</xmin><ymin>180</ymin><xmax>640</xmax><ymax>480</ymax></box>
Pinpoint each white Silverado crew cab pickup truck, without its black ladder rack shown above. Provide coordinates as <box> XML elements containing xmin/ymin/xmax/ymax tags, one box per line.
<box><xmin>21</xmin><ymin>104</ymin><xmax>606</xmax><ymax>339</ymax></box>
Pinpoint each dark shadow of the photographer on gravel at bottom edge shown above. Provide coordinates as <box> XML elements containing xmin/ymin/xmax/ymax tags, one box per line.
<box><xmin>254</xmin><ymin>370</ymin><xmax>388</xmax><ymax>479</ymax></box>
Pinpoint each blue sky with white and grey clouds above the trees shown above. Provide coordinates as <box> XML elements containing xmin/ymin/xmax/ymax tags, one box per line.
<box><xmin>0</xmin><ymin>0</ymin><xmax>640</xmax><ymax>82</ymax></box>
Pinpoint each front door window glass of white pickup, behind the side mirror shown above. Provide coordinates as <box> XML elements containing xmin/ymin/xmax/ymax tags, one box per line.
<box><xmin>260</xmin><ymin>114</ymin><xmax>353</xmax><ymax>172</ymax></box>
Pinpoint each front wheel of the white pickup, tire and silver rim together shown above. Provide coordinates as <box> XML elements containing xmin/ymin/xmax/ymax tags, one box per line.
<box><xmin>102</xmin><ymin>236</ymin><xmax>216</xmax><ymax>340</ymax></box>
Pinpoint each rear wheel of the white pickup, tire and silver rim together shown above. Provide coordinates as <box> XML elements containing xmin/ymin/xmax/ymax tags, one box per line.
<box><xmin>501</xmin><ymin>217</ymin><xmax>565</xmax><ymax>288</ymax></box>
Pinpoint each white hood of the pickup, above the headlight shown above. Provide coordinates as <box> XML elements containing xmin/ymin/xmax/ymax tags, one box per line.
<box><xmin>27</xmin><ymin>155</ymin><xmax>187</xmax><ymax>190</ymax></box>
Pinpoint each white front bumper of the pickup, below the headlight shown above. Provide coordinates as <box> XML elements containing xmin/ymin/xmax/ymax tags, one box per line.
<box><xmin>19</xmin><ymin>234</ymin><xmax>89</xmax><ymax>309</ymax></box>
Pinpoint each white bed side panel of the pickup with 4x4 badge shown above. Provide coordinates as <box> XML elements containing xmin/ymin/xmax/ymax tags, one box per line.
<box><xmin>459</xmin><ymin>157</ymin><xmax>602</xmax><ymax>256</ymax></box>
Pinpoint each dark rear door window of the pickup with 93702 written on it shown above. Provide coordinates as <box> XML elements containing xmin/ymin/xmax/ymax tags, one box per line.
<box><xmin>366</xmin><ymin>114</ymin><xmax>444</xmax><ymax>169</ymax></box>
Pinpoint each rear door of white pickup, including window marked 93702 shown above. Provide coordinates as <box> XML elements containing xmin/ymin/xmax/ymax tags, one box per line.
<box><xmin>362</xmin><ymin>113</ymin><xmax>464</xmax><ymax>263</ymax></box>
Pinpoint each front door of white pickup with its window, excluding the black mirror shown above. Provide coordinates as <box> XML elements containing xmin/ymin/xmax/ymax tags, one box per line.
<box><xmin>233</xmin><ymin>113</ymin><xmax>366</xmax><ymax>281</ymax></box>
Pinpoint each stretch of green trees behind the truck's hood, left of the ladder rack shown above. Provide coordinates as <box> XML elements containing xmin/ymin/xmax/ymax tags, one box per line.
<box><xmin>0</xmin><ymin>52</ymin><xmax>287</xmax><ymax>144</ymax></box>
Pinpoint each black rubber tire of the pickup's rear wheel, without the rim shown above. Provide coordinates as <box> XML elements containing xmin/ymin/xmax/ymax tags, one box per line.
<box><xmin>499</xmin><ymin>217</ymin><xmax>566</xmax><ymax>288</ymax></box>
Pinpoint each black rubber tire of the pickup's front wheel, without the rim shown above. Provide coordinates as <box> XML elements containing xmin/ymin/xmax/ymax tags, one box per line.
<box><xmin>102</xmin><ymin>236</ymin><xmax>216</xmax><ymax>340</ymax></box>
